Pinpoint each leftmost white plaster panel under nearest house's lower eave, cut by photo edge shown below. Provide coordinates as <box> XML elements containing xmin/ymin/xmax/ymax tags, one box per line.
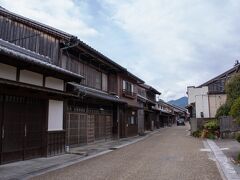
<box><xmin>0</xmin><ymin>63</ymin><xmax>17</xmax><ymax>81</ymax></box>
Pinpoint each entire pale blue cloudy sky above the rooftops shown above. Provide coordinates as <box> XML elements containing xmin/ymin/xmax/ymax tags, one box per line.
<box><xmin>0</xmin><ymin>0</ymin><xmax>240</xmax><ymax>100</ymax></box>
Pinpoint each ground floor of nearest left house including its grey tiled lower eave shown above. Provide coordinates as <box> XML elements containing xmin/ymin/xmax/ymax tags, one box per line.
<box><xmin>0</xmin><ymin>39</ymin><xmax>82</xmax><ymax>164</ymax></box>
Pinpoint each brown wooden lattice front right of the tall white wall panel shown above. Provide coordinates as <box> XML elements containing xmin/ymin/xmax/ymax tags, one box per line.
<box><xmin>66</xmin><ymin>104</ymin><xmax>113</xmax><ymax>147</ymax></box>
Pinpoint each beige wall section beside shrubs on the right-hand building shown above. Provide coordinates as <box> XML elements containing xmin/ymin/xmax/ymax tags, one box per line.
<box><xmin>209</xmin><ymin>94</ymin><xmax>227</xmax><ymax>118</ymax></box>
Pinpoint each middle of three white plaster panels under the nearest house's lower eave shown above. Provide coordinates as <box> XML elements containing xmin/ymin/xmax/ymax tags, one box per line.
<box><xmin>19</xmin><ymin>70</ymin><xmax>43</xmax><ymax>86</ymax></box>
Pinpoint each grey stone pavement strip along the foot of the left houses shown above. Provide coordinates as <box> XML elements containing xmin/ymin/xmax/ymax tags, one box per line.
<box><xmin>0</xmin><ymin>129</ymin><xmax>158</xmax><ymax>180</ymax></box>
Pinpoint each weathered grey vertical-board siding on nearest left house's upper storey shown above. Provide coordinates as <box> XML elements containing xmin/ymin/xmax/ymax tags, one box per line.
<box><xmin>0</xmin><ymin>16</ymin><xmax>59</xmax><ymax>65</ymax></box>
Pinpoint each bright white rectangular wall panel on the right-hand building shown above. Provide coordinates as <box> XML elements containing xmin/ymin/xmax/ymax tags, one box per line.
<box><xmin>195</xmin><ymin>94</ymin><xmax>209</xmax><ymax>118</ymax></box>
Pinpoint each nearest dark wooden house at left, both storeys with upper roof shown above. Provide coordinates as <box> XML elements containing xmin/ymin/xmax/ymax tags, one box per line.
<box><xmin>0</xmin><ymin>8</ymin><xmax>87</xmax><ymax>163</ymax></box>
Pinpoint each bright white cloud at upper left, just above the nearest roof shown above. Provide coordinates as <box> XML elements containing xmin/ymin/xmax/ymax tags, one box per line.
<box><xmin>0</xmin><ymin>0</ymin><xmax>98</xmax><ymax>39</ymax></box>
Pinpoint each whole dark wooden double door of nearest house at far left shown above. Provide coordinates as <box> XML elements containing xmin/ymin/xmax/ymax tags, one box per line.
<box><xmin>1</xmin><ymin>95</ymin><xmax>46</xmax><ymax>163</ymax></box>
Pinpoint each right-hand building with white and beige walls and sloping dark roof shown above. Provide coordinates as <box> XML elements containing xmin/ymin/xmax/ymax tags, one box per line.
<box><xmin>187</xmin><ymin>61</ymin><xmax>240</xmax><ymax>132</ymax></box>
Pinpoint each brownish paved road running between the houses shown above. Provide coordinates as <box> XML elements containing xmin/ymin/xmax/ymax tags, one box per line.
<box><xmin>34</xmin><ymin>127</ymin><xmax>221</xmax><ymax>180</ymax></box>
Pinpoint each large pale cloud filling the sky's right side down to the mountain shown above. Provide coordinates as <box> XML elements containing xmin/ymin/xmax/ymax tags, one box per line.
<box><xmin>100</xmin><ymin>0</ymin><xmax>240</xmax><ymax>99</ymax></box>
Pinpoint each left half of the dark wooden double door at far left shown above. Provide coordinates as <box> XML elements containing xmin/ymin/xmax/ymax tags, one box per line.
<box><xmin>1</xmin><ymin>96</ymin><xmax>25</xmax><ymax>163</ymax></box>
